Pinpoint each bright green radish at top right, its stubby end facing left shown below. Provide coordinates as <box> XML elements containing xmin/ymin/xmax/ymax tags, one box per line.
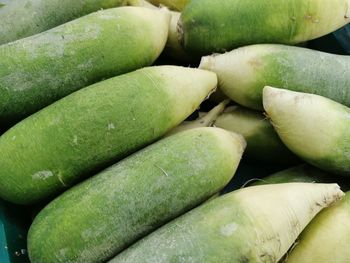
<box><xmin>179</xmin><ymin>0</ymin><xmax>350</xmax><ymax>55</ymax></box>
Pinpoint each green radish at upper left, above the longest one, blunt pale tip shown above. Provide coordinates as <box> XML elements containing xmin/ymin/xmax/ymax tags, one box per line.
<box><xmin>0</xmin><ymin>7</ymin><xmax>170</xmax><ymax>126</ymax></box>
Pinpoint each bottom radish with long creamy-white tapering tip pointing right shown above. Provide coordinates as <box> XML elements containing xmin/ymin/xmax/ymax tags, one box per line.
<box><xmin>109</xmin><ymin>183</ymin><xmax>344</xmax><ymax>263</ymax></box>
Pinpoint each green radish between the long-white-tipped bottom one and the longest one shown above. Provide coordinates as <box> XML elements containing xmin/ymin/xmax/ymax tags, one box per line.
<box><xmin>28</xmin><ymin>128</ymin><xmax>245</xmax><ymax>263</ymax></box>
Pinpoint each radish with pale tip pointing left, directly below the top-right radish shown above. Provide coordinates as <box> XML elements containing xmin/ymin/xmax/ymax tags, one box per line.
<box><xmin>200</xmin><ymin>44</ymin><xmax>350</xmax><ymax>110</ymax></box>
